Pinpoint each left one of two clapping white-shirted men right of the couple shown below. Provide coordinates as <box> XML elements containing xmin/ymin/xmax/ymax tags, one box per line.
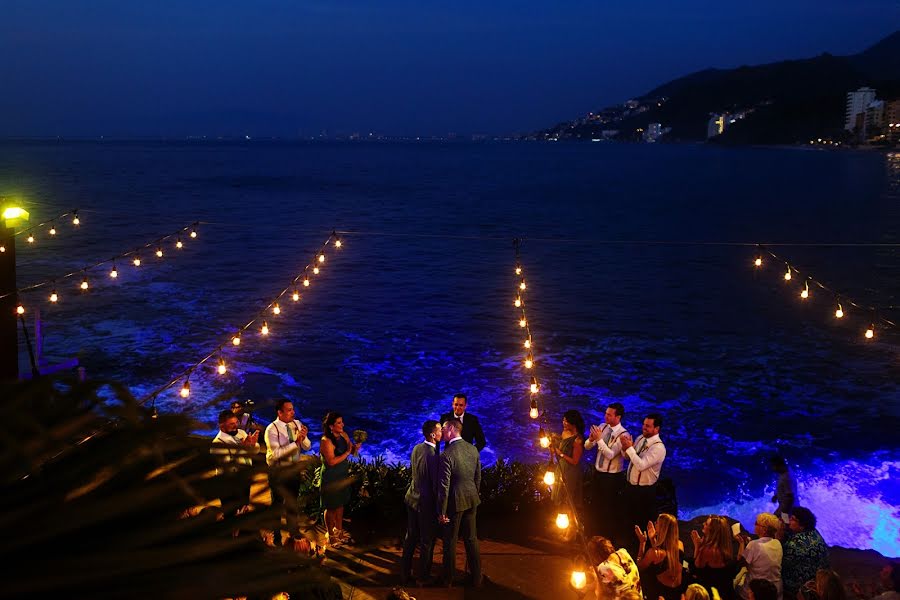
<box><xmin>584</xmin><ymin>402</ymin><xmax>628</xmax><ymax>539</ymax></box>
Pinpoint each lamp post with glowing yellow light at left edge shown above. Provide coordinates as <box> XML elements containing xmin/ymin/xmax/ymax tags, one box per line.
<box><xmin>0</xmin><ymin>205</ymin><xmax>28</xmax><ymax>381</ymax></box>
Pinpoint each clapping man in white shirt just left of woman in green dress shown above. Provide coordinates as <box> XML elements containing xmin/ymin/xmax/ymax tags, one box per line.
<box><xmin>265</xmin><ymin>399</ymin><xmax>312</xmax><ymax>541</ymax></box>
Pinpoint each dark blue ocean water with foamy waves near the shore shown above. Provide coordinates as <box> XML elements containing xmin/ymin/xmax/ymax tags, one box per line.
<box><xmin>0</xmin><ymin>141</ymin><xmax>900</xmax><ymax>556</ymax></box>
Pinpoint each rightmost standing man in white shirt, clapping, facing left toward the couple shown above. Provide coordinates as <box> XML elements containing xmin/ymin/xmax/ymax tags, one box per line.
<box><xmin>619</xmin><ymin>413</ymin><xmax>666</xmax><ymax>547</ymax></box>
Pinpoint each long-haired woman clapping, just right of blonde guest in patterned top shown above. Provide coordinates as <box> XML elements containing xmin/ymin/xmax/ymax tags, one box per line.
<box><xmin>634</xmin><ymin>513</ymin><xmax>684</xmax><ymax>600</ymax></box>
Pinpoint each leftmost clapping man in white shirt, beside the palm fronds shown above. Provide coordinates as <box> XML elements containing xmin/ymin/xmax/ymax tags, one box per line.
<box><xmin>209</xmin><ymin>410</ymin><xmax>259</xmax><ymax>513</ymax></box>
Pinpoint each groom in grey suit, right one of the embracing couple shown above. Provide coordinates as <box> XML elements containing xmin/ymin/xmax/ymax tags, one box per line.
<box><xmin>437</xmin><ymin>419</ymin><xmax>482</xmax><ymax>587</ymax></box>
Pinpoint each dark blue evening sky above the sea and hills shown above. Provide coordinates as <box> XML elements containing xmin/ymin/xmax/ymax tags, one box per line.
<box><xmin>0</xmin><ymin>0</ymin><xmax>900</xmax><ymax>137</ymax></box>
